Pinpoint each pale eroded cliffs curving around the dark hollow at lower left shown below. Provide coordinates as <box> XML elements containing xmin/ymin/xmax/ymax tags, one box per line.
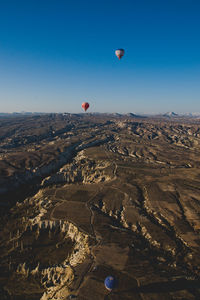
<box><xmin>0</xmin><ymin>191</ymin><xmax>90</xmax><ymax>299</ymax></box>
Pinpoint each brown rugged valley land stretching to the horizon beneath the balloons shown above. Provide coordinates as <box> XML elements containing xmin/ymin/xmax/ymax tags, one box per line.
<box><xmin>0</xmin><ymin>114</ymin><xmax>200</xmax><ymax>300</ymax></box>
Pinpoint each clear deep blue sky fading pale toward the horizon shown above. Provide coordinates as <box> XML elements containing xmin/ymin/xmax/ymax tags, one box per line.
<box><xmin>0</xmin><ymin>0</ymin><xmax>200</xmax><ymax>113</ymax></box>
